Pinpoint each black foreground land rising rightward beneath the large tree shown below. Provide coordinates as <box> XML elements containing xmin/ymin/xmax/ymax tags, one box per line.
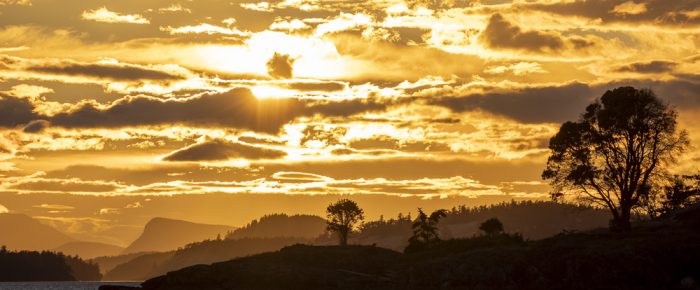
<box><xmin>103</xmin><ymin>207</ymin><xmax>700</xmax><ymax>290</ymax></box>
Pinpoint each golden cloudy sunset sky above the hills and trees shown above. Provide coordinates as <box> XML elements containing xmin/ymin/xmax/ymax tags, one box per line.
<box><xmin>0</xmin><ymin>0</ymin><xmax>700</xmax><ymax>244</ymax></box>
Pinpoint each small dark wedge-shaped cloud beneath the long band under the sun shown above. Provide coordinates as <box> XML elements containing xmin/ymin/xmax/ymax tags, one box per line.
<box><xmin>163</xmin><ymin>139</ymin><xmax>287</xmax><ymax>161</ymax></box>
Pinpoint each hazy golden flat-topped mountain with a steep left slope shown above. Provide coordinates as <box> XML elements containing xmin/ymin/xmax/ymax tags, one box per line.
<box><xmin>123</xmin><ymin>218</ymin><xmax>234</xmax><ymax>254</ymax></box>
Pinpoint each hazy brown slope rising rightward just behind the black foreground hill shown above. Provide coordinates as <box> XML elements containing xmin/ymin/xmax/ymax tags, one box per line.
<box><xmin>104</xmin><ymin>238</ymin><xmax>308</xmax><ymax>281</ymax></box>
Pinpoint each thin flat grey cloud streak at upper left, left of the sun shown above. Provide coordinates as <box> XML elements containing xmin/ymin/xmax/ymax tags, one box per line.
<box><xmin>26</xmin><ymin>60</ymin><xmax>185</xmax><ymax>81</ymax></box>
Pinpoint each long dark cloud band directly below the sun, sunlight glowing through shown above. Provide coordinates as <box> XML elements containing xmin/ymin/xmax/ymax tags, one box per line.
<box><xmin>46</xmin><ymin>88</ymin><xmax>386</xmax><ymax>133</ymax></box>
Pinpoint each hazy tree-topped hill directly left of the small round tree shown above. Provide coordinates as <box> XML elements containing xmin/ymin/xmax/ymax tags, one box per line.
<box><xmin>226</xmin><ymin>214</ymin><xmax>326</xmax><ymax>239</ymax></box>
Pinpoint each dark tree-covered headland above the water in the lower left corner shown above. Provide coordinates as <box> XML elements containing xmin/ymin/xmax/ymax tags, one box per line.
<box><xmin>0</xmin><ymin>246</ymin><xmax>102</xmax><ymax>281</ymax></box>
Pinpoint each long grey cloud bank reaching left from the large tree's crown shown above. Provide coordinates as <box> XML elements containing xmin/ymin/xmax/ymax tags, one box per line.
<box><xmin>431</xmin><ymin>83</ymin><xmax>594</xmax><ymax>123</ymax></box>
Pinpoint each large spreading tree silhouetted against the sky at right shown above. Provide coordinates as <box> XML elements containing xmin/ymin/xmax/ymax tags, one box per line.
<box><xmin>542</xmin><ymin>87</ymin><xmax>689</xmax><ymax>231</ymax></box>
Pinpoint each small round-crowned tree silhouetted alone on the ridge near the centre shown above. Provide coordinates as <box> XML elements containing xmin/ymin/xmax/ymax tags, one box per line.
<box><xmin>326</xmin><ymin>199</ymin><xmax>365</xmax><ymax>246</ymax></box>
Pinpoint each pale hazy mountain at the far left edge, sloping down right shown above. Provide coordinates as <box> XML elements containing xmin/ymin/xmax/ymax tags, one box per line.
<box><xmin>0</xmin><ymin>213</ymin><xmax>73</xmax><ymax>251</ymax></box>
